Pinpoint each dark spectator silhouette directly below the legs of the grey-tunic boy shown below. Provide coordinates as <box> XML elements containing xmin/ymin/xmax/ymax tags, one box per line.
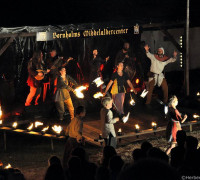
<box><xmin>101</xmin><ymin>146</ymin><xmax>117</xmax><ymax>168</ymax></box>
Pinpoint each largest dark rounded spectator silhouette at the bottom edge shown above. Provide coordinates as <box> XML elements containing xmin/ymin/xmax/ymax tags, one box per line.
<box><xmin>119</xmin><ymin>158</ymin><xmax>181</xmax><ymax>180</ymax></box>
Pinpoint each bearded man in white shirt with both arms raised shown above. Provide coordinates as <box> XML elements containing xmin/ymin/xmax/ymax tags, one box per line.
<box><xmin>144</xmin><ymin>45</ymin><xmax>177</xmax><ymax>104</ymax></box>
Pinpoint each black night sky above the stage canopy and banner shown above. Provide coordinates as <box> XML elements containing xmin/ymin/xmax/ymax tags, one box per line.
<box><xmin>0</xmin><ymin>0</ymin><xmax>200</xmax><ymax>27</ymax></box>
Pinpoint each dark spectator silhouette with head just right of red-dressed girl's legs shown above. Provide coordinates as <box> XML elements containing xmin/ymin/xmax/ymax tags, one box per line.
<box><xmin>171</xmin><ymin>130</ymin><xmax>186</xmax><ymax>168</ymax></box>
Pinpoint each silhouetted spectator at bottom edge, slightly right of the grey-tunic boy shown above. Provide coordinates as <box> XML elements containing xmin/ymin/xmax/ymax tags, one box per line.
<box><xmin>109</xmin><ymin>156</ymin><xmax>124</xmax><ymax>180</ymax></box>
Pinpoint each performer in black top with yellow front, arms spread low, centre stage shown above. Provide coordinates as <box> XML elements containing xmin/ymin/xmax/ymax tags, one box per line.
<box><xmin>104</xmin><ymin>62</ymin><xmax>137</xmax><ymax>115</ymax></box>
